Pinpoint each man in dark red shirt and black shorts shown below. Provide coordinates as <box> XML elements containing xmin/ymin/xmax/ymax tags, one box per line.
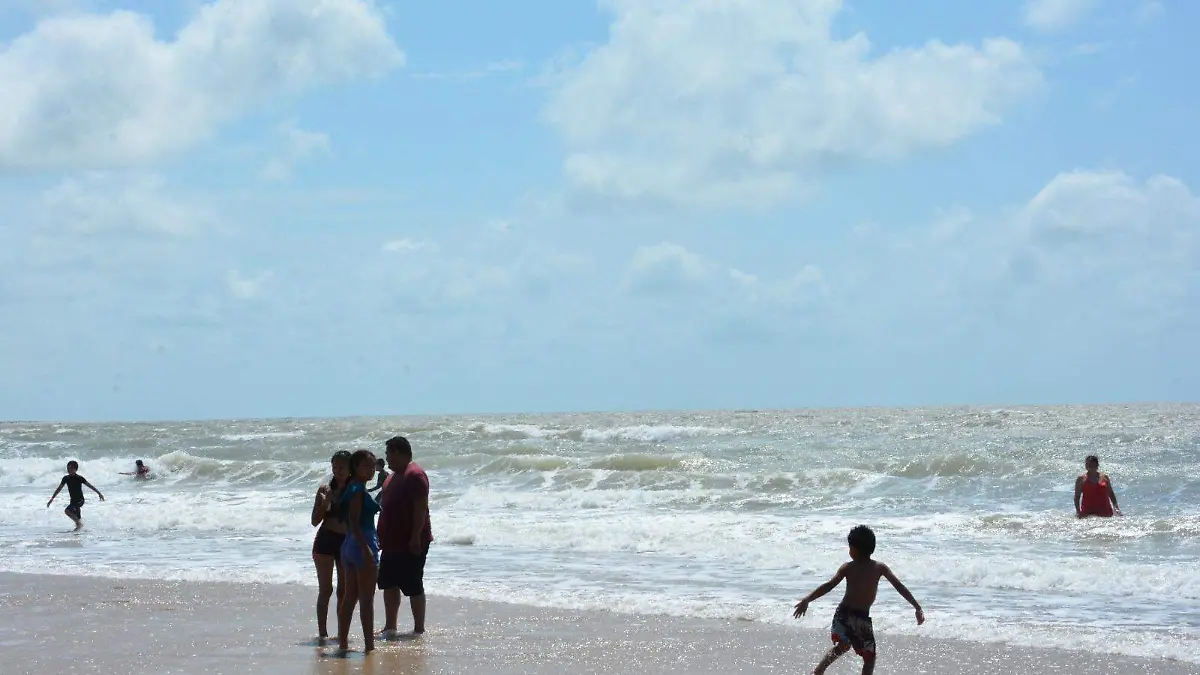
<box><xmin>378</xmin><ymin>436</ymin><xmax>433</xmax><ymax>638</ymax></box>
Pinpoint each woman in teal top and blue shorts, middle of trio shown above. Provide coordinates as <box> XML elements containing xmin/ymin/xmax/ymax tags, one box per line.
<box><xmin>337</xmin><ymin>450</ymin><xmax>379</xmax><ymax>653</ymax></box>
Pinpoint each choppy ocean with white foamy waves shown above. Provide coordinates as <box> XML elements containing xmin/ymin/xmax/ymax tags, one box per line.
<box><xmin>0</xmin><ymin>405</ymin><xmax>1200</xmax><ymax>663</ymax></box>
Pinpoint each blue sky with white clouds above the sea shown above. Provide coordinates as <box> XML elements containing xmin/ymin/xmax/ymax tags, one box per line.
<box><xmin>0</xmin><ymin>0</ymin><xmax>1200</xmax><ymax>420</ymax></box>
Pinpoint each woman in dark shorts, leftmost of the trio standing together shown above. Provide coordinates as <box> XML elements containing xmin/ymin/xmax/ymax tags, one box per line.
<box><xmin>312</xmin><ymin>450</ymin><xmax>350</xmax><ymax>640</ymax></box>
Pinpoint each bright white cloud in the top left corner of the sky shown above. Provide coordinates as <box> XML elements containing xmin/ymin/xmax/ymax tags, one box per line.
<box><xmin>0</xmin><ymin>0</ymin><xmax>404</xmax><ymax>168</ymax></box>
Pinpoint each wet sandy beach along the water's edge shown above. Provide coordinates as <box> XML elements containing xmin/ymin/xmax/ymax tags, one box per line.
<box><xmin>0</xmin><ymin>573</ymin><xmax>1200</xmax><ymax>675</ymax></box>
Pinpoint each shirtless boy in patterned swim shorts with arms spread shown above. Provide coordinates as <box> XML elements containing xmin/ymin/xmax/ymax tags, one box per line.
<box><xmin>792</xmin><ymin>525</ymin><xmax>925</xmax><ymax>675</ymax></box>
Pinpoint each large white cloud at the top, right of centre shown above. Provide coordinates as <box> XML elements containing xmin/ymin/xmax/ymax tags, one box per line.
<box><xmin>544</xmin><ymin>0</ymin><xmax>1042</xmax><ymax>204</ymax></box>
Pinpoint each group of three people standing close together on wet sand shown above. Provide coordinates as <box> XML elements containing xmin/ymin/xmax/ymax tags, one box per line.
<box><xmin>312</xmin><ymin>436</ymin><xmax>433</xmax><ymax>652</ymax></box>
